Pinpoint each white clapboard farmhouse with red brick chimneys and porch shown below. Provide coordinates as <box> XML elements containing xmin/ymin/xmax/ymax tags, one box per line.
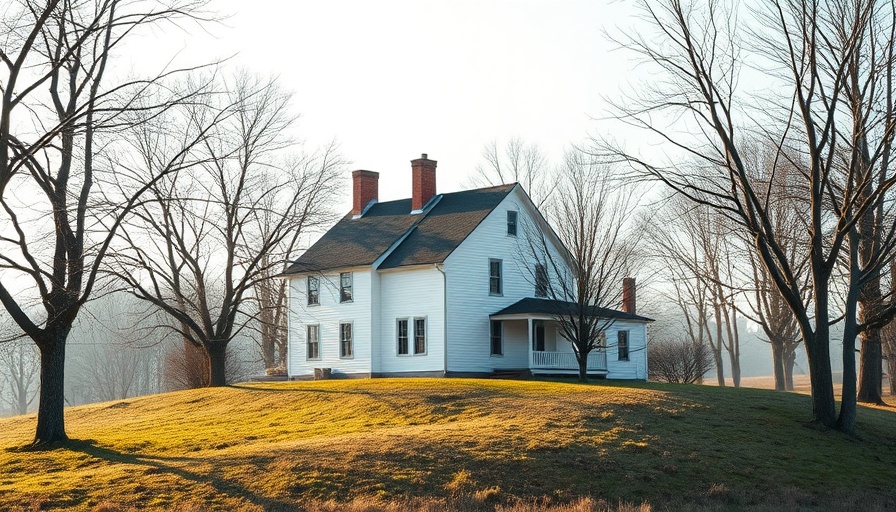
<box><xmin>284</xmin><ymin>154</ymin><xmax>651</xmax><ymax>379</ymax></box>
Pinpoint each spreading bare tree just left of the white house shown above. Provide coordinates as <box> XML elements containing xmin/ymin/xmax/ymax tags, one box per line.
<box><xmin>114</xmin><ymin>73</ymin><xmax>341</xmax><ymax>386</ymax></box>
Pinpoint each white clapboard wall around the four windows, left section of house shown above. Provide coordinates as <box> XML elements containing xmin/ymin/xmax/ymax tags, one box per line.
<box><xmin>289</xmin><ymin>269</ymin><xmax>372</xmax><ymax>377</ymax></box>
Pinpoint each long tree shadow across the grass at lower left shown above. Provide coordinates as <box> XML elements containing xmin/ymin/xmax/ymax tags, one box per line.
<box><xmin>64</xmin><ymin>439</ymin><xmax>297</xmax><ymax>512</ymax></box>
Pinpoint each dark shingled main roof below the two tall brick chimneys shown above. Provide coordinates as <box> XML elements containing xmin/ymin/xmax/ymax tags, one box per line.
<box><xmin>284</xmin><ymin>184</ymin><xmax>516</xmax><ymax>274</ymax></box>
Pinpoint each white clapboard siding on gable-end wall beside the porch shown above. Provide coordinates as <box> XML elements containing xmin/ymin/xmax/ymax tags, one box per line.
<box><xmin>445</xmin><ymin>187</ymin><xmax>568</xmax><ymax>372</ymax></box>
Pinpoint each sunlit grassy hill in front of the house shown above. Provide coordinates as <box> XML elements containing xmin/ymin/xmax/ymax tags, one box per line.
<box><xmin>0</xmin><ymin>379</ymin><xmax>896</xmax><ymax>512</ymax></box>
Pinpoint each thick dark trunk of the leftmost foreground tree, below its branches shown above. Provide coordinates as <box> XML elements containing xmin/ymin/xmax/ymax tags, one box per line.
<box><xmin>34</xmin><ymin>334</ymin><xmax>68</xmax><ymax>445</ymax></box>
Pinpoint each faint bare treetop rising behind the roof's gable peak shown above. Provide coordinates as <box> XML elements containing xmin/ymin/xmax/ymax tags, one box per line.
<box><xmin>469</xmin><ymin>137</ymin><xmax>557</xmax><ymax>209</ymax></box>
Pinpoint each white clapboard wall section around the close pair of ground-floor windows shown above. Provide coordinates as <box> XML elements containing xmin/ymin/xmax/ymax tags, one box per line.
<box><xmin>374</xmin><ymin>265</ymin><xmax>445</xmax><ymax>373</ymax></box>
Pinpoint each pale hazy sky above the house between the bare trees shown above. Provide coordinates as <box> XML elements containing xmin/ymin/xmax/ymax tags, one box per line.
<box><xmin>138</xmin><ymin>0</ymin><xmax>631</xmax><ymax>209</ymax></box>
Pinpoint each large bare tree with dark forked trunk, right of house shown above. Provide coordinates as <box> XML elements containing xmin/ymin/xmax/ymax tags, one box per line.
<box><xmin>603</xmin><ymin>0</ymin><xmax>894</xmax><ymax>432</ymax></box>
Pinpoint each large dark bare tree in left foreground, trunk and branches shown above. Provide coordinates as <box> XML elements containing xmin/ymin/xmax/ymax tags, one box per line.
<box><xmin>0</xmin><ymin>0</ymin><xmax>217</xmax><ymax>444</ymax></box>
